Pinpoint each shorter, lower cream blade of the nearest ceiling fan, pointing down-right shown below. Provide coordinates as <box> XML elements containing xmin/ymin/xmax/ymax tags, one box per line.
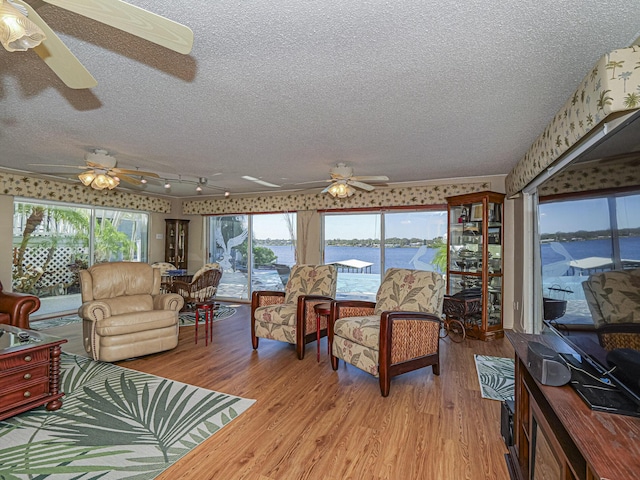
<box><xmin>15</xmin><ymin>0</ymin><xmax>98</xmax><ymax>89</ymax></box>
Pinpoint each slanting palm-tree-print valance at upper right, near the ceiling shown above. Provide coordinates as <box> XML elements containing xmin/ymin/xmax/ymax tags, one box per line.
<box><xmin>505</xmin><ymin>46</ymin><xmax>640</xmax><ymax>195</ymax></box>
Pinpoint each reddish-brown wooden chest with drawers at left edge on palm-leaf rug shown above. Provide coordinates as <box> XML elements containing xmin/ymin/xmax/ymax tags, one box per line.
<box><xmin>0</xmin><ymin>325</ymin><xmax>66</xmax><ymax>420</ymax></box>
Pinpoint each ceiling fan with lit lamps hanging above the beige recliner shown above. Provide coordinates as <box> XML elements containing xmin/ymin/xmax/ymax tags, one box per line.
<box><xmin>32</xmin><ymin>149</ymin><xmax>159</xmax><ymax>190</ymax></box>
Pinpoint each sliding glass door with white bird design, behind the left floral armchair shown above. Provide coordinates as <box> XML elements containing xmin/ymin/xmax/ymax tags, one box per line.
<box><xmin>208</xmin><ymin>213</ymin><xmax>296</xmax><ymax>300</ymax></box>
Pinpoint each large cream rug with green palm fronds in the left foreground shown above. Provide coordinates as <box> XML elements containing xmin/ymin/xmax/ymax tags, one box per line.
<box><xmin>0</xmin><ymin>353</ymin><xmax>254</xmax><ymax>480</ymax></box>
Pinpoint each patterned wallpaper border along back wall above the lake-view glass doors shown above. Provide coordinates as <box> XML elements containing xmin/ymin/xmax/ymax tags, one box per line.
<box><xmin>182</xmin><ymin>182</ymin><xmax>491</xmax><ymax>215</ymax></box>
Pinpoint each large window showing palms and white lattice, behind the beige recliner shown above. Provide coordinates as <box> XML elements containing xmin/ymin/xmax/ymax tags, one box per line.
<box><xmin>12</xmin><ymin>199</ymin><xmax>149</xmax><ymax>315</ymax></box>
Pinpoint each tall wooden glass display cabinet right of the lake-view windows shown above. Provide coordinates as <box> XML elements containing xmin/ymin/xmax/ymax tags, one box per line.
<box><xmin>443</xmin><ymin>192</ymin><xmax>504</xmax><ymax>340</ymax></box>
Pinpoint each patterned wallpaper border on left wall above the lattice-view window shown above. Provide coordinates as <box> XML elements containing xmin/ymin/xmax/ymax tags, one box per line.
<box><xmin>0</xmin><ymin>172</ymin><xmax>171</xmax><ymax>213</ymax></box>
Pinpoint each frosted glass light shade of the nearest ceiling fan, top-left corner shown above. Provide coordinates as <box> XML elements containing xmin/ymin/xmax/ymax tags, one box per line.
<box><xmin>0</xmin><ymin>0</ymin><xmax>47</xmax><ymax>52</ymax></box>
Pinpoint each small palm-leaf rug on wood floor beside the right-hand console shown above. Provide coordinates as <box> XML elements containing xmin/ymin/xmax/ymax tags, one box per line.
<box><xmin>474</xmin><ymin>355</ymin><xmax>515</xmax><ymax>401</ymax></box>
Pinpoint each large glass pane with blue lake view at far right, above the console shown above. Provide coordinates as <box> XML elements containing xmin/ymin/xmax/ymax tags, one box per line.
<box><xmin>538</xmin><ymin>193</ymin><xmax>640</xmax><ymax>324</ymax></box>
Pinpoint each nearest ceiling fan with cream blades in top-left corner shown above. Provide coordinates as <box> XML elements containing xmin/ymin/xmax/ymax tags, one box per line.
<box><xmin>0</xmin><ymin>0</ymin><xmax>193</xmax><ymax>89</ymax></box>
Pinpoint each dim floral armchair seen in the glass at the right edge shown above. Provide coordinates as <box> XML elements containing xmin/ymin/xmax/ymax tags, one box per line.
<box><xmin>582</xmin><ymin>268</ymin><xmax>640</xmax><ymax>350</ymax></box>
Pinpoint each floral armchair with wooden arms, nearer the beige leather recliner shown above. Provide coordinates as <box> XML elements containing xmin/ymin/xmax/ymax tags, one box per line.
<box><xmin>251</xmin><ymin>265</ymin><xmax>338</xmax><ymax>360</ymax></box>
